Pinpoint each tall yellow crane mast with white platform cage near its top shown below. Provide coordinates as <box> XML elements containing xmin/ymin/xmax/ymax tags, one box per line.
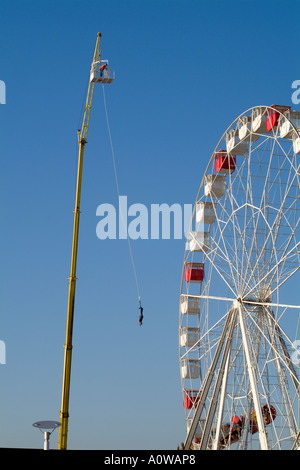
<box><xmin>59</xmin><ymin>33</ymin><xmax>114</xmax><ymax>450</ymax></box>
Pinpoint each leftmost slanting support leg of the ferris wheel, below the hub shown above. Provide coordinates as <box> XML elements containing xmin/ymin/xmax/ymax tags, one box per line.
<box><xmin>184</xmin><ymin>309</ymin><xmax>233</xmax><ymax>450</ymax></box>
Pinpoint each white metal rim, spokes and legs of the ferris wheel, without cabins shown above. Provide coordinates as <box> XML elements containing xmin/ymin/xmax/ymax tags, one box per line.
<box><xmin>179</xmin><ymin>105</ymin><xmax>300</xmax><ymax>450</ymax></box>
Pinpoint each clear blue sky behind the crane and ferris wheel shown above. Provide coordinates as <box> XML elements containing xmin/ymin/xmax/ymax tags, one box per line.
<box><xmin>0</xmin><ymin>0</ymin><xmax>300</xmax><ymax>449</ymax></box>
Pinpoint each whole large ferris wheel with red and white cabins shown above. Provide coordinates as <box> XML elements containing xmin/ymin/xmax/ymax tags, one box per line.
<box><xmin>179</xmin><ymin>105</ymin><xmax>300</xmax><ymax>450</ymax></box>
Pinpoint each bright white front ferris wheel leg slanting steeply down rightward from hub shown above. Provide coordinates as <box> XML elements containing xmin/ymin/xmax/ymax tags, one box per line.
<box><xmin>239</xmin><ymin>304</ymin><xmax>269</xmax><ymax>450</ymax></box>
